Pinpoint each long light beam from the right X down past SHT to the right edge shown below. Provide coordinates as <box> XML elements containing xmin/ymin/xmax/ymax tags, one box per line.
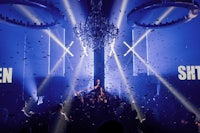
<box><xmin>133</xmin><ymin>51</ymin><xmax>200</xmax><ymax>117</ymax></box>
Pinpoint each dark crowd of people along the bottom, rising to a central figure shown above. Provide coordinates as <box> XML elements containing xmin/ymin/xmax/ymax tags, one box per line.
<box><xmin>0</xmin><ymin>80</ymin><xmax>198</xmax><ymax>133</ymax></box>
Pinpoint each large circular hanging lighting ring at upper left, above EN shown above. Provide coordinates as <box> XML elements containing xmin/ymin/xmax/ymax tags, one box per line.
<box><xmin>0</xmin><ymin>0</ymin><xmax>63</xmax><ymax>28</ymax></box>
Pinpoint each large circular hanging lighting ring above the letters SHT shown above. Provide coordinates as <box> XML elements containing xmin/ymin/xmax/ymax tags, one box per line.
<box><xmin>127</xmin><ymin>0</ymin><xmax>199</xmax><ymax>29</ymax></box>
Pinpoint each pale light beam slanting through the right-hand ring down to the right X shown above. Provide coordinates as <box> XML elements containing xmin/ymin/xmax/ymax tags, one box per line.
<box><xmin>124</xmin><ymin>7</ymin><xmax>175</xmax><ymax>56</ymax></box>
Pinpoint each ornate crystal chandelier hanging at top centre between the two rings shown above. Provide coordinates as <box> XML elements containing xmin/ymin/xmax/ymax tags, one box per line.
<box><xmin>74</xmin><ymin>0</ymin><xmax>119</xmax><ymax>50</ymax></box>
